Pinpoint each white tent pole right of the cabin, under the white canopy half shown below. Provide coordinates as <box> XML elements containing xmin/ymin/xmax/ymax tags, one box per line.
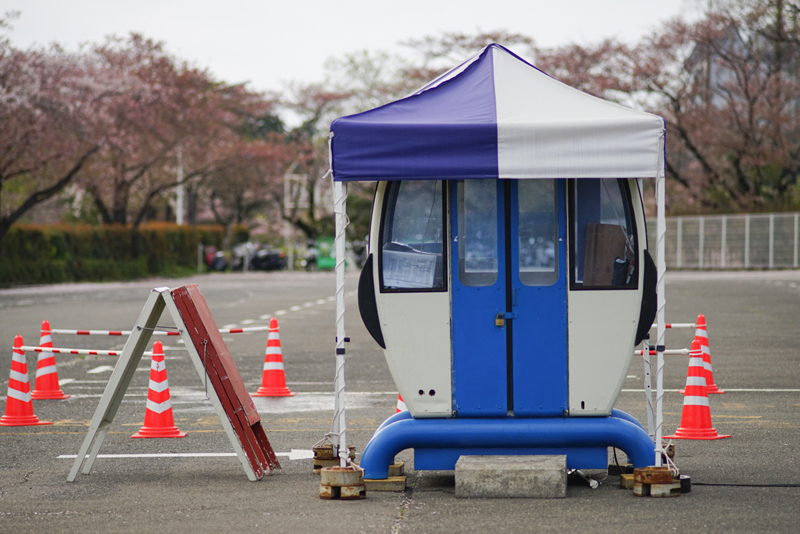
<box><xmin>654</xmin><ymin>140</ymin><xmax>667</xmax><ymax>467</ymax></box>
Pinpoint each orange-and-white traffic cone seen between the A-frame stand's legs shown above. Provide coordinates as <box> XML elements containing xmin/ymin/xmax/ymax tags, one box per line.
<box><xmin>131</xmin><ymin>341</ymin><xmax>186</xmax><ymax>438</ymax></box>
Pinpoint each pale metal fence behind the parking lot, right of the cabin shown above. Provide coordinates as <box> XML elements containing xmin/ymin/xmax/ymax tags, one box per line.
<box><xmin>647</xmin><ymin>213</ymin><xmax>800</xmax><ymax>269</ymax></box>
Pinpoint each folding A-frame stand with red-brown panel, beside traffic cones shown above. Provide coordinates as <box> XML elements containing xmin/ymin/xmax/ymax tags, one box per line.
<box><xmin>67</xmin><ymin>285</ymin><xmax>280</xmax><ymax>482</ymax></box>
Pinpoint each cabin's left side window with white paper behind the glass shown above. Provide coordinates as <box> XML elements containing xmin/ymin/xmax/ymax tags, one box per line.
<box><xmin>380</xmin><ymin>180</ymin><xmax>446</xmax><ymax>291</ymax></box>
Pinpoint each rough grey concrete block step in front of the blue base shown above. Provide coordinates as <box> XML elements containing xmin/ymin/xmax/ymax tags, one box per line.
<box><xmin>456</xmin><ymin>455</ymin><xmax>567</xmax><ymax>499</ymax></box>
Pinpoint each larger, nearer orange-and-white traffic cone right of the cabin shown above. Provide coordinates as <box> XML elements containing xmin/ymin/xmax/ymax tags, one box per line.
<box><xmin>664</xmin><ymin>340</ymin><xmax>730</xmax><ymax>439</ymax></box>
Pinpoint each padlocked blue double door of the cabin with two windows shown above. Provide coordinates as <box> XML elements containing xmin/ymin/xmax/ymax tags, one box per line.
<box><xmin>450</xmin><ymin>180</ymin><xmax>568</xmax><ymax>417</ymax></box>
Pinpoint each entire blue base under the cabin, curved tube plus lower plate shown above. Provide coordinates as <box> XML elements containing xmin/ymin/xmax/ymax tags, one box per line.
<box><xmin>361</xmin><ymin>410</ymin><xmax>655</xmax><ymax>479</ymax></box>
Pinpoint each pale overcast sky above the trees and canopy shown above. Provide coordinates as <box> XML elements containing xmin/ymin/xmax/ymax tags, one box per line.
<box><xmin>0</xmin><ymin>0</ymin><xmax>696</xmax><ymax>91</ymax></box>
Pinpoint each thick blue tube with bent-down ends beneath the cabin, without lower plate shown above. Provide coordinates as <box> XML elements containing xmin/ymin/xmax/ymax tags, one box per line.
<box><xmin>361</xmin><ymin>414</ymin><xmax>655</xmax><ymax>479</ymax></box>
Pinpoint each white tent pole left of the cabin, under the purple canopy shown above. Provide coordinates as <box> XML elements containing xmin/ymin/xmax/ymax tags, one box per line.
<box><xmin>333</xmin><ymin>176</ymin><xmax>349</xmax><ymax>467</ymax></box>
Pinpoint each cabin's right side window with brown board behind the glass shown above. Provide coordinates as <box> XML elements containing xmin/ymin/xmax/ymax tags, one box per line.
<box><xmin>570</xmin><ymin>179</ymin><xmax>639</xmax><ymax>289</ymax></box>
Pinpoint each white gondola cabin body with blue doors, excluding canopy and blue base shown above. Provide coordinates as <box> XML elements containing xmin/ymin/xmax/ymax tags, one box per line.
<box><xmin>360</xmin><ymin>179</ymin><xmax>645</xmax><ymax>418</ymax></box>
